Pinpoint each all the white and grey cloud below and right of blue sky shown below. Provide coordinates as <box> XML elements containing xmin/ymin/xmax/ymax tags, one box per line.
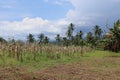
<box><xmin>0</xmin><ymin>0</ymin><xmax>120</xmax><ymax>39</ymax></box>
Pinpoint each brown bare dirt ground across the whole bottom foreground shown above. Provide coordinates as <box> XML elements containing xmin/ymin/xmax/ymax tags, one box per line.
<box><xmin>0</xmin><ymin>58</ymin><xmax>120</xmax><ymax>80</ymax></box>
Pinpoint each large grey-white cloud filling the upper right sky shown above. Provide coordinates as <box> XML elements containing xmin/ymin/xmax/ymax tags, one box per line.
<box><xmin>66</xmin><ymin>0</ymin><xmax>120</xmax><ymax>26</ymax></box>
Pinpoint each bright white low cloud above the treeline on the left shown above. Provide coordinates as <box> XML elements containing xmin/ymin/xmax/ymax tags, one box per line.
<box><xmin>0</xmin><ymin>17</ymin><xmax>68</xmax><ymax>38</ymax></box>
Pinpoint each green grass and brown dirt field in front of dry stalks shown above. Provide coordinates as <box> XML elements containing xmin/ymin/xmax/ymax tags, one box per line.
<box><xmin>0</xmin><ymin>48</ymin><xmax>120</xmax><ymax>80</ymax></box>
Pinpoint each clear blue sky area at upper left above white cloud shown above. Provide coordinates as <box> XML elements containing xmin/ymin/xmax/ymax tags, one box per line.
<box><xmin>0</xmin><ymin>0</ymin><xmax>72</xmax><ymax>21</ymax></box>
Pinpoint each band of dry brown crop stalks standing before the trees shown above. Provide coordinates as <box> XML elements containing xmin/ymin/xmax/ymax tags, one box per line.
<box><xmin>0</xmin><ymin>44</ymin><xmax>93</xmax><ymax>62</ymax></box>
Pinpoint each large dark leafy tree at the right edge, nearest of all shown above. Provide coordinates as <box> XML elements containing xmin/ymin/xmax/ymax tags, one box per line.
<box><xmin>105</xmin><ymin>20</ymin><xmax>120</xmax><ymax>52</ymax></box>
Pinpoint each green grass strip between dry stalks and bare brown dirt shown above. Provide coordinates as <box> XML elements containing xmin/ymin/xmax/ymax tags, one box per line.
<box><xmin>0</xmin><ymin>51</ymin><xmax>120</xmax><ymax>71</ymax></box>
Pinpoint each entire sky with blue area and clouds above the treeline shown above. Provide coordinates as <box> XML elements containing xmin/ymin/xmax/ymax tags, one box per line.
<box><xmin>0</xmin><ymin>0</ymin><xmax>120</xmax><ymax>40</ymax></box>
